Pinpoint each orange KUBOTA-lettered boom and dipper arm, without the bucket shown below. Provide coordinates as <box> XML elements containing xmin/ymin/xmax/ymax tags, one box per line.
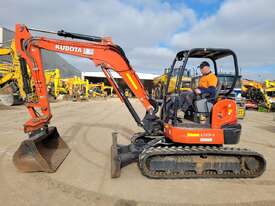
<box><xmin>15</xmin><ymin>24</ymin><xmax>155</xmax><ymax>132</ymax></box>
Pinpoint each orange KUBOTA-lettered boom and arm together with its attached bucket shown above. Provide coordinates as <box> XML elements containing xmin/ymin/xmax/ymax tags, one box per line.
<box><xmin>14</xmin><ymin>24</ymin><xmax>158</xmax><ymax>172</ymax></box>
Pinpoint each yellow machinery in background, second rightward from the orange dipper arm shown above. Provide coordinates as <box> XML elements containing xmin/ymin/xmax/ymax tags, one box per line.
<box><xmin>63</xmin><ymin>76</ymin><xmax>89</xmax><ymax>101</ymax></box>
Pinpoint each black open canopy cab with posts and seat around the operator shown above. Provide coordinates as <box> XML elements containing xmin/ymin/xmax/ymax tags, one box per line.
<box><xmin>161</xmin><ymin>48</ymin><xmax>239</xmax><ymax>127</ymax></box>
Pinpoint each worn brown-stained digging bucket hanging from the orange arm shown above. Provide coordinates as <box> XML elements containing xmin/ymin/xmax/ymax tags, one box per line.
<box><xmin>13</xmin><ymin>127</ymin><xmax>70</xmax><ymax>172</ymax></box>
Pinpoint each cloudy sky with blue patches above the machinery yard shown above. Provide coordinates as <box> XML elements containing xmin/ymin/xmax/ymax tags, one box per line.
<box><xmin>0</xmin><ymin>0</ymin><xmax>275</xmax><ymax>80</ymax></box>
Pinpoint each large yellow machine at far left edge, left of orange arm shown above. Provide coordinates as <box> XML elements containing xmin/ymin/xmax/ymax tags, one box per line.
<box><xmin>0</xmin><ymin>40</ymin><xmax>26</xmax><ymax>106</ymax></box>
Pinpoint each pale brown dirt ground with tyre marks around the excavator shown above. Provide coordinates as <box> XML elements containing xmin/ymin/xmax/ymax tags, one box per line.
<box><xmin>0</xmin><ymin>99</ymin><xmax>275</xmax><ymax>206</ymax></box>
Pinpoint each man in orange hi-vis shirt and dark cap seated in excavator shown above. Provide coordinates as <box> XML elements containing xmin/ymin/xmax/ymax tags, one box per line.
<box><xmin>166</xmin><ymin>61</ymin><xmax>218</xmax><ymax>117</ymax></box>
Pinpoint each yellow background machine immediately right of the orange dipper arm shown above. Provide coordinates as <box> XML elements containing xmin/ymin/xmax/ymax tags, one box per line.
<box><xmin>44</xmin><ymin>68</ymin><xmax>68</xmax><ymax>99</ymax></box>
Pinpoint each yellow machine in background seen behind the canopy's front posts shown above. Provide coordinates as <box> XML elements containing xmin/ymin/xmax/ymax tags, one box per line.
<box><xmin>153</xmin><ymin>68</ymin><xmax>191</xmax><ymax>99</ymax></box>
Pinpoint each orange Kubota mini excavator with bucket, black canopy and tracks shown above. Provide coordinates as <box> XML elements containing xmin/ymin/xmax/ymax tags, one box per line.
<box><xmin>13</xmin><ymin>24</ymin><xmax>265</xmax><ymax>179</ymax></box>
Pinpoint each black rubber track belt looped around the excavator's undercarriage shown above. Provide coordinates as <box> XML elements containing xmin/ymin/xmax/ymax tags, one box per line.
<box><xmin>138</xmin><ymin>146</ymin><xmax>266</xmax><ymax>179</ymax></box>
